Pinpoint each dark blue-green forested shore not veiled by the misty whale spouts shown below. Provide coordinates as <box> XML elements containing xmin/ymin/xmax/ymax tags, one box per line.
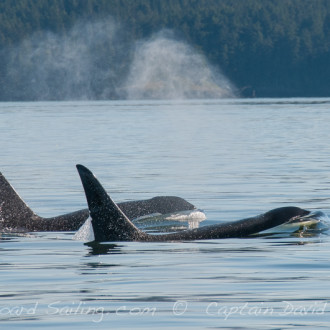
<box><xmin>0</xmin><ymin>0</ymin><xmax>330</xmax><ymax>100</ymax></box>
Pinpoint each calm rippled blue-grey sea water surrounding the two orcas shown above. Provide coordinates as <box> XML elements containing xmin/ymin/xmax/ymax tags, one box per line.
<box><xmin>0</xmin><ymin>99</ymin><xmax>330</xmax><ymax>329</ymax></box>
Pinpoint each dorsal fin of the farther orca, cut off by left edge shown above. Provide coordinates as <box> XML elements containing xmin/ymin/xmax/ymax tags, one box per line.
<box><xmin>0</xmin><ymin>173</ymin><xmax>40</xmax><ymax>229</ymax></box>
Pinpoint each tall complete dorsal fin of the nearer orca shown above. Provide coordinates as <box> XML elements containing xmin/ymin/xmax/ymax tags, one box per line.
<box><xmin>77</xmin><ymin>165</ymin><xmax>146</xmax><ymax>242</ymax></box>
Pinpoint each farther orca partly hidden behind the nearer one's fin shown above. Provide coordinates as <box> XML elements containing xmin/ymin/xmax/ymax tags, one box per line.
<box><xmin>0</xmin><ymin>173</ymin><xmax>196</xmax><ymax>232</ymax></box>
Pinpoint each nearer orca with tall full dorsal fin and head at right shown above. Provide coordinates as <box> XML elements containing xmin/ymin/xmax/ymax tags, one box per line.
<box><xmin>77</xmin><ymin>164</ymin><xmax>310</xmax><ymax>242</ymax></box>
